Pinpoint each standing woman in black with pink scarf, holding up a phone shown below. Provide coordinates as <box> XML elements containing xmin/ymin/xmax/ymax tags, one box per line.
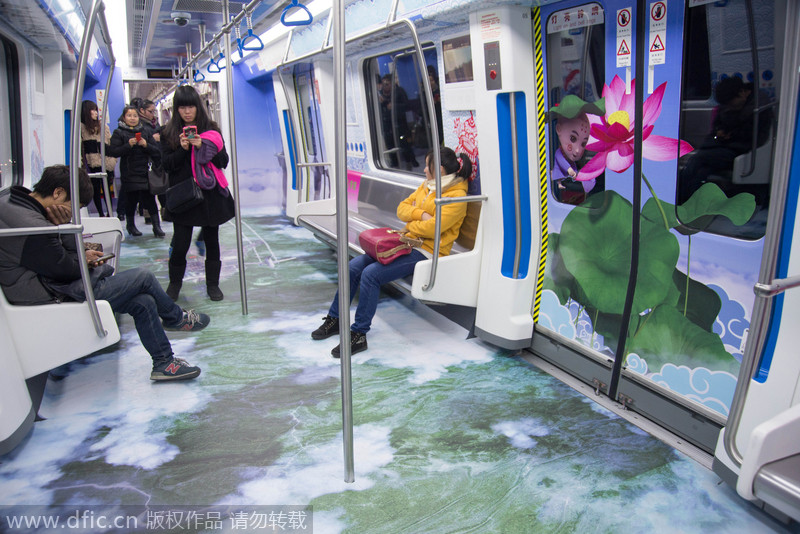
<box><xmin>161</xmin><ymin>85</ymin><xmax>235</xmax><ymax>300</ymax></box>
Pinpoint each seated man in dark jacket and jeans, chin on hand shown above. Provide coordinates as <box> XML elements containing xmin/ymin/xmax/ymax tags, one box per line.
<box><xmin>0</xmin><ymin>165</ymin><xmax>210</xmax><ymax>380</ymax></box>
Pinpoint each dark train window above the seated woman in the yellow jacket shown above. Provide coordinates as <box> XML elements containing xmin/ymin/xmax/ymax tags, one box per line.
<box><xmin>364</xmin><ymin>45</ymin><xmax>442</xmax><ymax>175</ymax></box>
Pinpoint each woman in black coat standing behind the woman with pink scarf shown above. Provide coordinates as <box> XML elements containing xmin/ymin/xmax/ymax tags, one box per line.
<box><xmin>109</xmin><ymin>106</ymin><xmax>165</xmax><ymax>237</ymax></box>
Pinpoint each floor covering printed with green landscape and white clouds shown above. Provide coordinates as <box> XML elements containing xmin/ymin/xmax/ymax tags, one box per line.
<box><xmin>0</xmin><ymin>214</ymin><xmax>796</xmax><ymax>533</ymax></box>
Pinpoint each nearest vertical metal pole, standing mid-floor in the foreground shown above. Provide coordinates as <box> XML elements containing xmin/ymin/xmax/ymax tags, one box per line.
<box><xmin>331</xmin><ymin>0</ymin><xmax>355</xmax><ymax>482</ymax></box>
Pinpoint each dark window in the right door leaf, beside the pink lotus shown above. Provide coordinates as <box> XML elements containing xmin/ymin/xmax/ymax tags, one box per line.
<box><xmin>675</xmin><ymin>0</ymin><xmax>780</xmax><ymax>239</ymax></box>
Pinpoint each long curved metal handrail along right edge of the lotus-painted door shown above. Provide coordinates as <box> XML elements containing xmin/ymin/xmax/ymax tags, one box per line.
<box><xmin>723</xmin><ymin>2</ymin><xmax>800</xmax><ymax>474</ymax></box>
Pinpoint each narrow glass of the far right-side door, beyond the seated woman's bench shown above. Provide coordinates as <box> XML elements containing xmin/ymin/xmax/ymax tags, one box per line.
<box><xmin>294</xmin><ymin>65</ymin><xmax>331</xmax><ymax>200</ymax></box>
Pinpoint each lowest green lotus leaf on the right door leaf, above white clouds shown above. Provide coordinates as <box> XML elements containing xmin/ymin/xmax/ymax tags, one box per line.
<box><xmin>625</xmin><ymin>306</ymin><xmax>739</xmax><ymax>374</ymax></box>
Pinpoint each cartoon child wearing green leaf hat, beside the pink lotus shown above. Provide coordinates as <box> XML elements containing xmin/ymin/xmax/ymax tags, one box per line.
<box><xmin>550</xmin><ymin>95</ymin><xmax>605</xmax><ymax>204</ymax></box>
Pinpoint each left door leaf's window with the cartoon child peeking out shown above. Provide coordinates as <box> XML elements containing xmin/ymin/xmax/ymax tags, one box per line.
<box><xmin>546</xmin><ymin>3</ymin><xmax>606</xmax><ymax>205</ymax></box>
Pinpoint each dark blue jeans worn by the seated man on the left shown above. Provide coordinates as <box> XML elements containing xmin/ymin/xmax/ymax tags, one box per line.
<box><xmin>94</xmin><ymin>269</ymin><xmax>183</xmax><ymax>362</ymax></box>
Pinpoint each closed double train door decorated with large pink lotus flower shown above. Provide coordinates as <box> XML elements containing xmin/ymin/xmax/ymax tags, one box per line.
<box><xmin>533</xmin><ymin>0</ymin><xmax>785</xmax><ymax>451</ymax></box>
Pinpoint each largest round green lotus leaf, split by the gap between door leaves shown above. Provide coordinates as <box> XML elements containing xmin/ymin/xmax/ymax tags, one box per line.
<box><xmin>558</xmin><ymin>191</ymin><xmax>680</xmax><ymax>314</ymax></box>
